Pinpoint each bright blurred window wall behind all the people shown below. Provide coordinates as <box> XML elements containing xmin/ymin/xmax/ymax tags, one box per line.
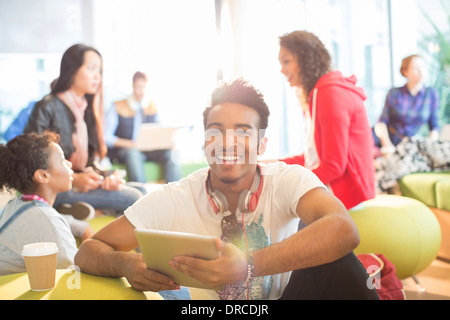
<box><xmin>0</xmin><ymin>0</ymin><xmax>450</xmax><ymax>162</ymax></box>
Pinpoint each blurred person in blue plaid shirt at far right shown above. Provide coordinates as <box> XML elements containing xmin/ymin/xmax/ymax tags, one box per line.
<box><xmin>374</xmin><ymin>54</ymin><xmax>439</xmax><ymax>154</ymax></box>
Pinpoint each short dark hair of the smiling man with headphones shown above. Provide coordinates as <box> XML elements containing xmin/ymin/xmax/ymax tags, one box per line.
<box><xmin>203</xmin><ymin>78</ymin><xmax>270</xmax><ymax>132</ymax></box>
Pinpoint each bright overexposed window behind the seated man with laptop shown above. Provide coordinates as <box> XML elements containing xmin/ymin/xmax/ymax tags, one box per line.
<box><xmin>94</xmin><ymin>0</ymin><xmax>219</xmax><ymax>162</ymax></box>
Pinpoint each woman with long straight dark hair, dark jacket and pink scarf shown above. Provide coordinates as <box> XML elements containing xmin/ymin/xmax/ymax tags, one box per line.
<box><xmin>24</xmin><ymin>44</ymin><xmax>142</xmax><ymax>215</ymax></box>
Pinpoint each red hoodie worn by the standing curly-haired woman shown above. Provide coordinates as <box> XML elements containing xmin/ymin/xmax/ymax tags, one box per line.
<box><xmin>281</xmin><ymin>71</ymin><xmax>375</xmax><ymax>209</ymax></box>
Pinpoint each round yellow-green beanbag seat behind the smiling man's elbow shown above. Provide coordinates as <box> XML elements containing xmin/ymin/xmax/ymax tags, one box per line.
<box><xmin>349</xmin><ymin>195</ymin><xmax>441</xmax><ymax>279</ymax></box>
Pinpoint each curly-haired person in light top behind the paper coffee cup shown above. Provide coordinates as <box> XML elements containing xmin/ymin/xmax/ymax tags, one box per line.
<box><xmin>0</xmin><ymin>132</ymin><xmax>86</xmax><ymax>275</ymax></box>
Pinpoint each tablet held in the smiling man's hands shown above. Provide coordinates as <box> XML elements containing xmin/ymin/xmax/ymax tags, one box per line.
<box><xmin>135</xmin><ymin>229</ymin><xmax>219</xmax><ymax>289</ymax></box>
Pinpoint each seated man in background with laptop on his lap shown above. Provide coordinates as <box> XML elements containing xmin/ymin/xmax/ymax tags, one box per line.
<box><xmin>105</xmin><ymin>71</ymin><xmax>181</xmax><ymax>183</ymax></box>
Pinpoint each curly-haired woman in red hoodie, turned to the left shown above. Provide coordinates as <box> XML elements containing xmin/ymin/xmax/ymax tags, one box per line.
<box><xmin>279</xmin><ymin>31</ymin><xmax>375</xmax><ymax>209</ymax></box>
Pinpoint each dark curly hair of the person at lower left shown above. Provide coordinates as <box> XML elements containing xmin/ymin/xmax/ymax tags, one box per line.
<box><xmin>0</xmin><ymin>131</ymin><xmax>59</xmax><ymax>193</ymax></box>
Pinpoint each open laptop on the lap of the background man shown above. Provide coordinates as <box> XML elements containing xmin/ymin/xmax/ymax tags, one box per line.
<box><xmin>135</xmin><ymin>123</ymin><xmax>180</xmax><ymax>151</ymax></box>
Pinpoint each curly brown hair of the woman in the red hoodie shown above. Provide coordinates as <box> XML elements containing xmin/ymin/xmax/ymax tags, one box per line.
<box><xmin>280</xmin><ymin>30</ymin><xmax>332</xmax><ymax>99</ymax></box>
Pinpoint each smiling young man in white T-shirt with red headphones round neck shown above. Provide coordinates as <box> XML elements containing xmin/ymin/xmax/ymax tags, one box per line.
<box><xmin>75</xmin><ymin>79</ymin><xmax>377</xmax><ymax>299</ymax></box>
